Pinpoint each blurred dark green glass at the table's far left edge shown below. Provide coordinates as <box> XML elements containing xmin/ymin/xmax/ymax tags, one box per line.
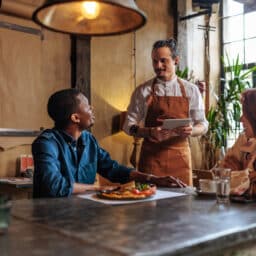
<box><xmin>0</xmin><ymin>194</ymin><xmax>11</xmax><ymax>235</ymax></box>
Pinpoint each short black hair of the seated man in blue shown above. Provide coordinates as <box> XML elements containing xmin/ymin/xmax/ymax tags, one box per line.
<box><xmin>47</xmin><ymin>88</ymin><xmax>81</xmax><ymax>128</ymax></box>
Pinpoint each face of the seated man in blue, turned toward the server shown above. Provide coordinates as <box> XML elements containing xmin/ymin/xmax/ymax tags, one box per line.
<box><xmin>77</xmin><ymin>94</ymin><xmax>95</xmax><ymax>131</ymax></box>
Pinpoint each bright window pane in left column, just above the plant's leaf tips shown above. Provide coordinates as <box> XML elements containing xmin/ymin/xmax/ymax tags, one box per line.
<box><xmin>224</xmin><ymin>41</ymin><xmax>244</xmax><ymax>63</ymax></box>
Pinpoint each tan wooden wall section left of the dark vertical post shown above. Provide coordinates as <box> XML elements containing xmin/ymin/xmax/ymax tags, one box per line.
<box><xmin>0</xmin><ymin>15</ymin><xmax>71</xmax><ymax>176</ymax></box>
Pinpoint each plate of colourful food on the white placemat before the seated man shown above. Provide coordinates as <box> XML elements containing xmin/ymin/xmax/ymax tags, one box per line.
<box><xmin>97</xmin><ymin>182</ymin><xmax>156</xmax><ymax>200</ymax></box>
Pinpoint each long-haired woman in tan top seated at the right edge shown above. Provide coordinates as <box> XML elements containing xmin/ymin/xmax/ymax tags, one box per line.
<box><xmin>220</xmin><ymin>89</ymin><xmax>256</xmax><ymax>194</ymax></box>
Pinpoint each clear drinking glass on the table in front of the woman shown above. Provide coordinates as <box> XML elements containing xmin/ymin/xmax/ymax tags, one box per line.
<box><xmin>213</xmin><ymin>167</ymin><xmax>231</xmax><ymax>204</ymax></box>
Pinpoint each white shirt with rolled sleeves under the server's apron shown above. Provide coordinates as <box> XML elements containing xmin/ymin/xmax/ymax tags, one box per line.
<box><xmin>123</xmin><ymin>77</ymin><xmax>208</xmax><ymax>134</ymax></box>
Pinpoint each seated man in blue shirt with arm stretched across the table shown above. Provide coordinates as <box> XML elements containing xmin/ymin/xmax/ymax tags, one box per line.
<box><xmin>32</xmin><ymin>89</ymin><xmax>186</xmax><ymax>198</ymax></box>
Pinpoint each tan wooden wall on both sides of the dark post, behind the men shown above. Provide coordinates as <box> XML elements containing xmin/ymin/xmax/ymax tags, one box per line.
<box><xmin>0</xmin><ymin>0</ymin><xmax>173</xmax><ymax>176</ymax></box>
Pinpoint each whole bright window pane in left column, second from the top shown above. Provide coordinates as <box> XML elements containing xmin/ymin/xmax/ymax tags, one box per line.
<box><xmin>223</xmin><ymin>15</ymin><xmax>244</xmax><ymax>43</ymax></box>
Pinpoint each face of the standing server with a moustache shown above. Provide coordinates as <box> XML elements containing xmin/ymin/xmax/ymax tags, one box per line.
<box><xmin>151</xmin><ymin>47</ymin><xmax>178</xmax><ymax>81</ymax></box>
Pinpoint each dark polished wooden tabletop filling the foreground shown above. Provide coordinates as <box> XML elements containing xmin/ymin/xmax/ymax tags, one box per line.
<box><xmin>0</xmin><ymin>189</ymin><xmax>256</xmax><ymax>256</ymax></box>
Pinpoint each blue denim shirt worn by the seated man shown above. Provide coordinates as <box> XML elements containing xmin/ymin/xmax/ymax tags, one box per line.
<box><xmin>32</xmin><ymin>128</ymin><xmax>133</xmax><ymax>197</ymax></box>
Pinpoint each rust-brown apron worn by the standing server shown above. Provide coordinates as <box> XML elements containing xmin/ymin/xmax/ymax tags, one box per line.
<box><xmin>139</xmin><ymin>79</ymin><xmax>192</xmax><ymax>185</ymax></box>
